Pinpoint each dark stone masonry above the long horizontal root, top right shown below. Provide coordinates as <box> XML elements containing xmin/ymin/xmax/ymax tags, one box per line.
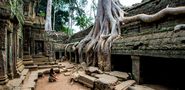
<box><xmin>125</xmin><ymin>0</ymin><xmax>185</xmax><ymax>16</ymax></box>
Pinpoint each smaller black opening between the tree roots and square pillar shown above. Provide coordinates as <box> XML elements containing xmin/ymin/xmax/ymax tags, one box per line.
<box><xmin>111</xmin><ymin>55</ymin><xmax>132</xmax><ymax>72</ymax></box>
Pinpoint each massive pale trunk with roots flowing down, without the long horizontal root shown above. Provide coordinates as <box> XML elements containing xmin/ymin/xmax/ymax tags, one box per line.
<box><xmin>77</xmin><ymin>0</ymin><xmax>123</xmax><ymax>71</ymax></box>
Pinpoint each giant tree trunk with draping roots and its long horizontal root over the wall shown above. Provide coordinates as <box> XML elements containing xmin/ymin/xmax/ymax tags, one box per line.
<box><xmin>65</xmin><ymin>0</ymin><xmax>185</xmax><ymax>71</ymax></box>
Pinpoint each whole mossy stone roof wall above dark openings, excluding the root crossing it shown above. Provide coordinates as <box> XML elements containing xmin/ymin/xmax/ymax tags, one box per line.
<box><xmin>112</xmin><ymin>0</ymin><xmax>185</xmax><ymax>58</ymax></box>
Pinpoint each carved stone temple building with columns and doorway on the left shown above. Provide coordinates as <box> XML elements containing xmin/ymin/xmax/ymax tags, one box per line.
<box><xmin>0</xmin><ymin>0</ymin><xmax>53</xmax><ymax>87</ymax></box>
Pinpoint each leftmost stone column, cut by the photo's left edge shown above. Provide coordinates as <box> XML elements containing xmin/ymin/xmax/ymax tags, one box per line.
<box><xmin>0</xmin><ymin>20</ymin><xmax>8</xmax><ymax>84</ymax></box>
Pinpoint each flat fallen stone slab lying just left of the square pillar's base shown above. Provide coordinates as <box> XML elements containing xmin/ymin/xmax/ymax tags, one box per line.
<box><xmin>109</xmin><ymin>71</ymin><xmax>129</xmax><ymax>80</ymax></box>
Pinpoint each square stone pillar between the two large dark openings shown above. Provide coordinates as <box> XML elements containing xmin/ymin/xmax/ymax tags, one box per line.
<box><xmin>131</xmin><ymin>56</ymin><xmax>140</xmax><ymax>83</ymax></box>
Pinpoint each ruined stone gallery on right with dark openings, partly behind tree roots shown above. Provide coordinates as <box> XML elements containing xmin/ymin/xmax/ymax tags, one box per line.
<box><xmin>63</xmin><ymin>0</ymin><xmax>185</xmax><ymax>87</ymax></box>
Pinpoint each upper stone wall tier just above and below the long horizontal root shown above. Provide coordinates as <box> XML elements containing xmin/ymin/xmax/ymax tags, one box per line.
<box><xmin>121</xmin><ymin>0</ymin><xmax>185</xmax><ymax>36</ymax></box>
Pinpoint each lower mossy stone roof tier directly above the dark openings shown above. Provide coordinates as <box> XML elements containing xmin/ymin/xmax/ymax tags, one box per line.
<box><xmin>112</xmin><ymin>30</ymin><xmax>185</xmax><ymax>59</ymax></box>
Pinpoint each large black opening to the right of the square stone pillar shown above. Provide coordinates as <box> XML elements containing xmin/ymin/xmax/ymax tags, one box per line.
<box><xmin>140</xmin><ymin>57</ymin><xmax>185</xmax><ymax>90</ymax></box>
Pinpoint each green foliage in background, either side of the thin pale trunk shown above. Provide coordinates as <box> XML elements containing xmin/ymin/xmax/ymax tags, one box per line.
<box><xmin>37</xmin><ymin>0</ymin><xmax>92</xmax><ymax>35</ymax></box>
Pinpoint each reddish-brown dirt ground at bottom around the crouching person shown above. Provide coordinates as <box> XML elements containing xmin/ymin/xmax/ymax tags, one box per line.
<box><xmin>36</xmin><ymin>73</ymin><xmax>90</xmax><ymax>90</ymax></box>
